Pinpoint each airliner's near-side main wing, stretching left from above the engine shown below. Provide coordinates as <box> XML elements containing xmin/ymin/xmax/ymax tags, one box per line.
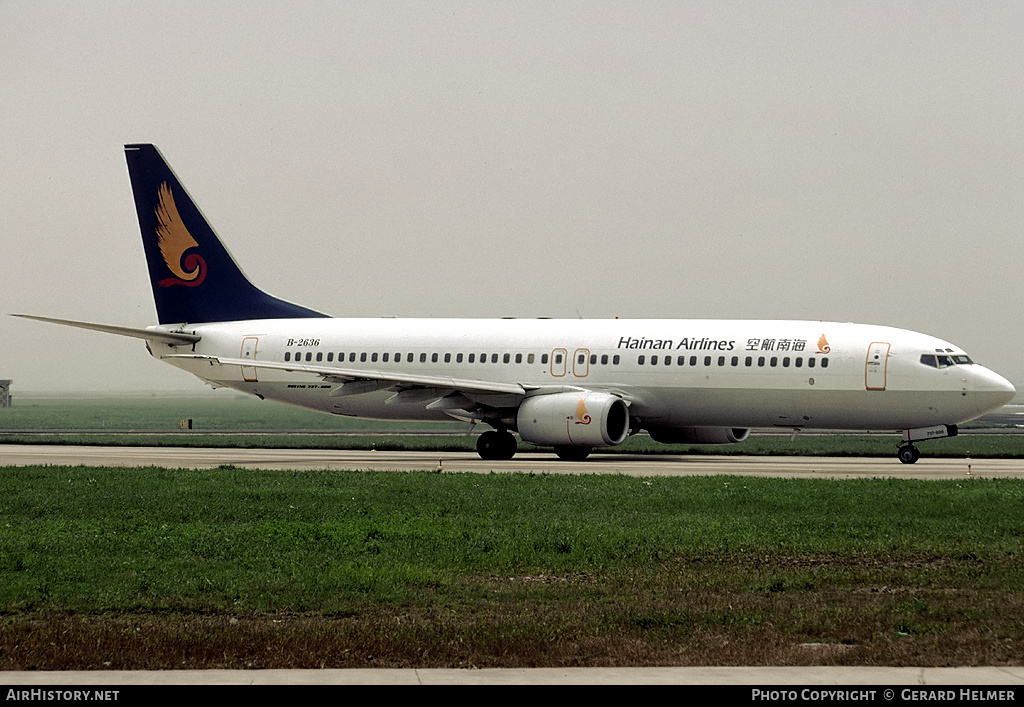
<box><xmin>161</xmin><ymin>354</ymin><xmax>538</xmax><ymax>407</ymax></box>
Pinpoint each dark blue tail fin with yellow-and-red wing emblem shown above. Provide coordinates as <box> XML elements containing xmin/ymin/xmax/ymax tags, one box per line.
<box><xmin>125</xmin><ymin>144</ymin><xmax>326</xmax><ymax>324</ymax></box>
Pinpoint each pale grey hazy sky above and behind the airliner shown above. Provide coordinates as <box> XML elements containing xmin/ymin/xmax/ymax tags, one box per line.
<box><xmin>0</xmin><ymin>0</ymin><xmax>1024</xmax><ymax>396</ymax></box>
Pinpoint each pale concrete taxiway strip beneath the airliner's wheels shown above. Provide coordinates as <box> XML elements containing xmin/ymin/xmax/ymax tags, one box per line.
<box><xmin>0</xmin><ymin>445</ymin><xmax>1024</xmax><ymax>479</ymax></box>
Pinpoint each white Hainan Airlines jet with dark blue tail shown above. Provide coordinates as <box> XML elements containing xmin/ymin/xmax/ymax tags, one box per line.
<box><xmin>18</xmin><ymin>144</ymin><xmax>1015</xmax><ymax>463</ymax></box>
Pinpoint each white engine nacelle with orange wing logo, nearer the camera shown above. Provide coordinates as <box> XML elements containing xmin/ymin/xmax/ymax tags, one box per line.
<box><xmin>516</xmin><ymin>391</ymin><xmax>630</xmax><ymax>447</ymax></box>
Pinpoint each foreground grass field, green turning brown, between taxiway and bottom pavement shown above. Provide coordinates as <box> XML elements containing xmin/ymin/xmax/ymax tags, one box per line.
<box><xmin>0</xmin><ymin>467</ymin><xmax>1024</xmax><ymax>670</ymax></box>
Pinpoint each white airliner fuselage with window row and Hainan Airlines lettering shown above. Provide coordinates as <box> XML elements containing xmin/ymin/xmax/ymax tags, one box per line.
<box><xmin>151</xmin><ymin>319</ymin><xmax>1015</xmax><ymax>430</ymax></box>
